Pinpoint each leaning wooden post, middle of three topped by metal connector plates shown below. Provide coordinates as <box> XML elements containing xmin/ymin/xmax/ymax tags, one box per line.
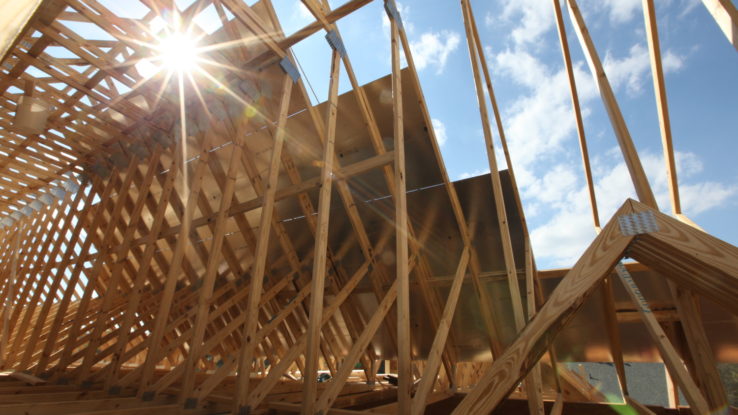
<box><xmin>302</xmin><ymin>50</ymin><xmax>341</xmax><ymax>415</ymax></box>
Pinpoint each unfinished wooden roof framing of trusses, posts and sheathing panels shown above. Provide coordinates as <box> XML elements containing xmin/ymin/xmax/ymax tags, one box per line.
<box><xmin>0</xmin><ymin>0</ymin><xmax>738</xmax><ymax>415</ymax></box>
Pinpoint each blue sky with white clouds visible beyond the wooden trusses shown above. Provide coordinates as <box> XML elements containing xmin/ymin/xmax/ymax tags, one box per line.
<box><xmin>92</xmin><ymin>0</ymin><xmax>738</xmax><ymax>268</ymax></box>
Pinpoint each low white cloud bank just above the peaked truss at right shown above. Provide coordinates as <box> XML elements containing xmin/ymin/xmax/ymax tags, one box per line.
<box><xmin>524</xmin><ymin>151</ymin><xmax>738</xmax><ymax>266</ymax></box>
